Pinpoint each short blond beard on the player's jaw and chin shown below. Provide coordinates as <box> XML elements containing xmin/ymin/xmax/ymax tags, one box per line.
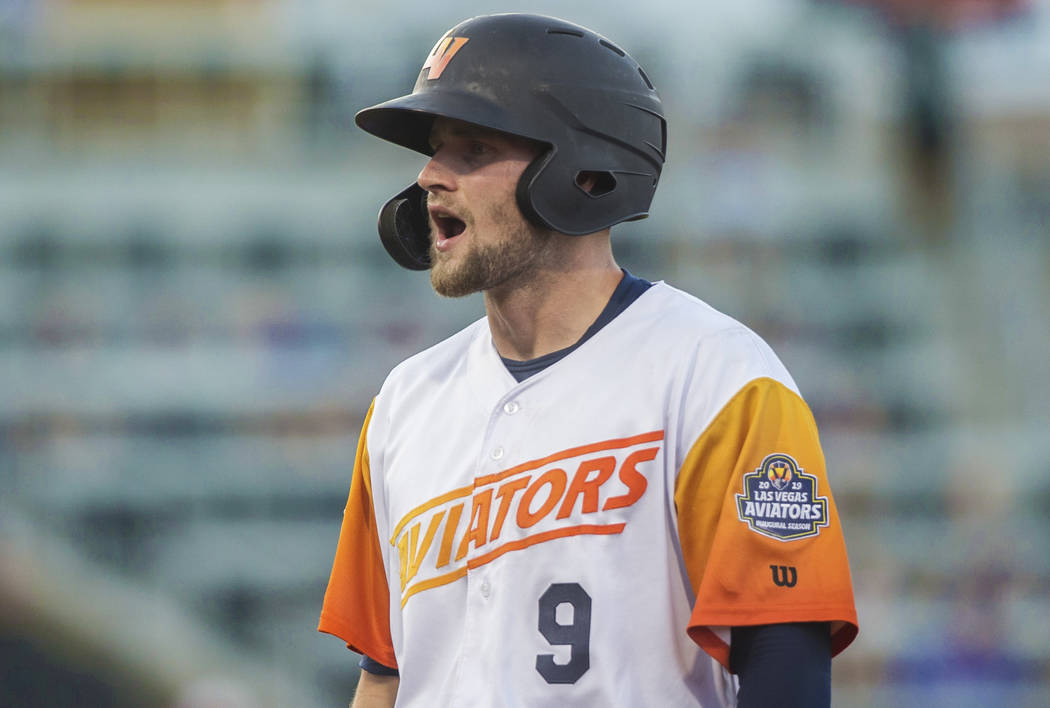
<box><xmin>431</xmin><ymin>201</ymin><xmax>553</xmax><ymax>297</ymax></box>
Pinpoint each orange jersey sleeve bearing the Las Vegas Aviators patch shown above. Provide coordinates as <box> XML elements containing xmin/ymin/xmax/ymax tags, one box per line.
<box><xmin>674</xmin><ymin>378</ymin><xmax>857</xmax><ymax>668</ymax></box>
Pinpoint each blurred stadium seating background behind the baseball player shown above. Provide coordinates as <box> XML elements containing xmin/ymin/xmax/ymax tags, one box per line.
<box><xmin>0</xmin><ymin>0</ymin><xmax>1050</xmax><ymax>708</ymax></box>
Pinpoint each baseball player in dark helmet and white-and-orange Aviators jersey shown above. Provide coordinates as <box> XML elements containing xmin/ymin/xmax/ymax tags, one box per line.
<box><xmin>319</xmin><ymin>15</ymin><xmax>857</xmax><ymax>708</ymax></box>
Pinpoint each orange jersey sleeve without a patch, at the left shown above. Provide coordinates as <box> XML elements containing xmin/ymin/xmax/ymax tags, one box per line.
<box><xmin>317</xmin><ymin>402</ymin><xmax>397</xmax><ymax>667</ymax></box>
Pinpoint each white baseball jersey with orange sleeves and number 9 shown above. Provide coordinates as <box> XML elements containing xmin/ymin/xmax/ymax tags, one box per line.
<box><xmin>319</xmin><ymin>283</ymin><xmax>857</xmax><ymax>708</ymax></box>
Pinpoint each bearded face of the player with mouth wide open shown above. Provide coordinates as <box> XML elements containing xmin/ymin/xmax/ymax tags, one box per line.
<box><xmin>418</xmin><ymin>119</ymin><xmax>553</xmax><ymax>297</ymax></box>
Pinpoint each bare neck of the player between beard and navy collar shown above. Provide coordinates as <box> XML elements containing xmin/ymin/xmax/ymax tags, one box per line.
<box><xmin>485</xmin><ymin>236</ymin><xmax>623</xmax><ymax>361</ymax></box>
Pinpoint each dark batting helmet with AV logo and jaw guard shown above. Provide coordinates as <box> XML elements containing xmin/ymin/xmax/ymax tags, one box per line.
<box><xmin>356</xmin><ymin>14</ymin><xmax>667</xmax><ymax>270</ymax></box>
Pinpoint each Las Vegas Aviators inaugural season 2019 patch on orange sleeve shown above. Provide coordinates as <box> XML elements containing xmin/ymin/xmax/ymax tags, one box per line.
<box><xmin>736</xmin><ymin>453</ymin><xmax>827</xmax><ymax>541</ymax></box>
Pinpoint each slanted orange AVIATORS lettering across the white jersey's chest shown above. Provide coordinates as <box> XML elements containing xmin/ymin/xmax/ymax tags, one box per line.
<box><xmin>391</xmin><ymin>431</ymin><xmax>664</xmax><ymax>607</ymax></box>
